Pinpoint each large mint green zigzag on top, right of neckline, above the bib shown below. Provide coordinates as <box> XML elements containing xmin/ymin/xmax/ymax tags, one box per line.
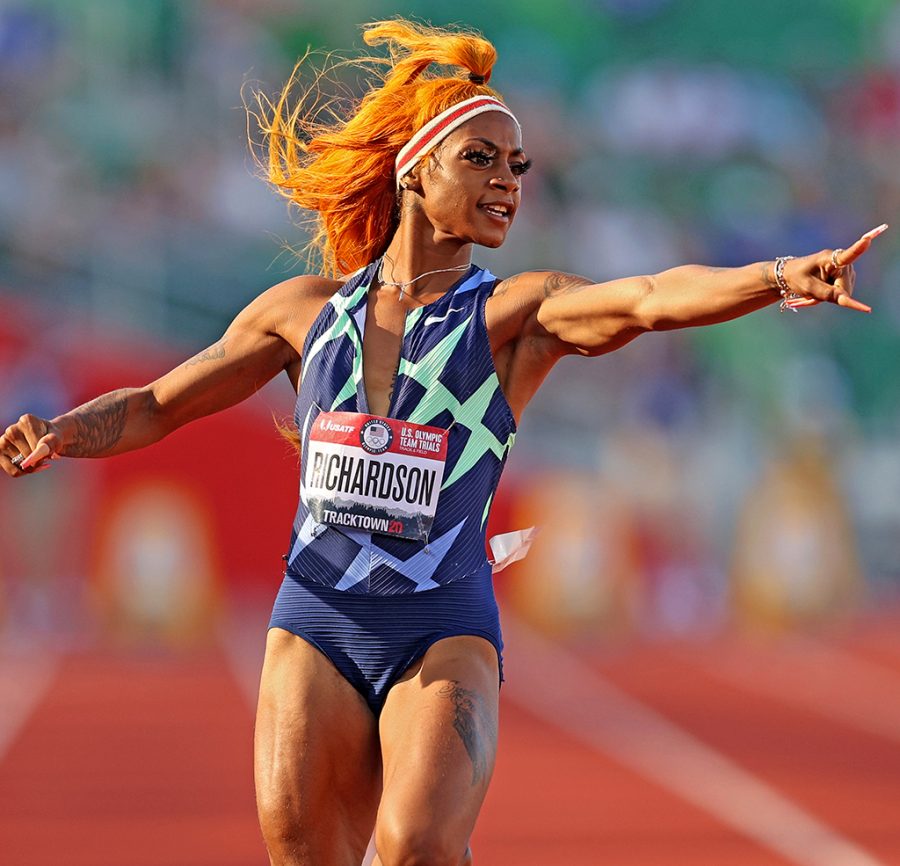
<box><xmin>398</xmin><ymin>316</ymin><xmax>515</xmax><ymax>490</ymax></box>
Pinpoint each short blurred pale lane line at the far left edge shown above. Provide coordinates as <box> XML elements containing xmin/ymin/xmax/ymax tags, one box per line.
<box><xmin>0</xmin><ymin>650</ymin><xmax>59</xmax><ymax>761</ymax></box>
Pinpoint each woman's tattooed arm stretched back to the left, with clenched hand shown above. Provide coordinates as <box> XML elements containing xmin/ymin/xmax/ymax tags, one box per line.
<box><xmin>0</xmin><ymin>277</ymin><xmax>331</xmax><ymax>477</ymax></box>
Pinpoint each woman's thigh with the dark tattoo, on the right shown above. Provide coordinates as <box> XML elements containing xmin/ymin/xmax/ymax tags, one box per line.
<box><xmin>375</xmin><ymin>636</ymin><xmax>499</xmax><ymax>866</ymax></box>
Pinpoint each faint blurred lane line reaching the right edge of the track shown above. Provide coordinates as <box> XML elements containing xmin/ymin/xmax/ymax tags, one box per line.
<box><xmin>692</xmin><ymin>638</ymin><xmax>900</xmax><ymax>742</ymax></box>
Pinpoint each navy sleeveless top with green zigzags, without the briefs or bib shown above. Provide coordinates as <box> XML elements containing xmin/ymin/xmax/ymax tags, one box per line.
<box><xmin>287</xmin><ymin>262</ymin><xmax>515</xmax><ymax>595</ymax></box>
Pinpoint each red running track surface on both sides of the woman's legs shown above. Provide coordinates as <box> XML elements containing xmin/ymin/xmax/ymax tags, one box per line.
<box><xmin>0</xmin><ymin>623</ymin><xmax>900</xmax><ymax>866</ymax></box>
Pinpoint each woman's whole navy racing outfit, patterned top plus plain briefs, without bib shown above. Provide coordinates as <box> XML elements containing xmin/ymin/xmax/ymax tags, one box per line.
<box><xmin>269</xmin><ymin>262</ymin><xmax>515</xmax><ymax>716</ymax></box>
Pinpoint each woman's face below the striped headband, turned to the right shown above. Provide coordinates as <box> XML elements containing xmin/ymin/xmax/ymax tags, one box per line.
<box><xmin>418</xmin><ymin>111</ymin><xmax>529</xmax><ymax>247</ymax></box>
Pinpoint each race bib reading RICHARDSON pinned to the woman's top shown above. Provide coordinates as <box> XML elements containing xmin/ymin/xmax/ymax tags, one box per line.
<box><xmin>300</xmin><ymin>412</ymin><xmax>447</xmax><ymax>541</ymax></box>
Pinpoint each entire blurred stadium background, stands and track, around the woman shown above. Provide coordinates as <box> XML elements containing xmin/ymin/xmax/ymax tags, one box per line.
<box><xmin>0</xmin><ymin>0</ymin><xmax>900</xmax><ymax>866</ymax></box>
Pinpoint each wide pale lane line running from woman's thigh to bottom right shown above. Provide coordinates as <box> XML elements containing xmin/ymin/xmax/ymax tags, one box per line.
<box><xmin>503</xmin><ymin>612</ymin><xmax>886</xmax><ymax>866</ymax></box>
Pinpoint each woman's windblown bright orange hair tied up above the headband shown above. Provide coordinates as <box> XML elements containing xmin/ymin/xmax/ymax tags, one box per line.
<box><xmin>257</xmin><ymin>19</ymin><xmax>499</xmax><ymax>277</ymax></box>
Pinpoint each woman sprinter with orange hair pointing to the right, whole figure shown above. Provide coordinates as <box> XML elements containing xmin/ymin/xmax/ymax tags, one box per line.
<box><xmin>0</xmin><ymin>20</ymin><xmax>883</xmax><ymax>866</ymax></box>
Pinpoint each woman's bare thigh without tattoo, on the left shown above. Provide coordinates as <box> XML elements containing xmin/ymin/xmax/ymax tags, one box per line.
<box><xmin>255</xmin><ymin>628</ymin><xmax>381</xmax><ymax>866</ymax></box>
